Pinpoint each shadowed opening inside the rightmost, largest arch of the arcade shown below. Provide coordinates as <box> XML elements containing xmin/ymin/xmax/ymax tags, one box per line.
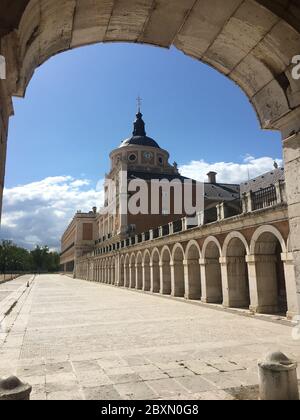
<box><xmin>254</xmin><ymin>232</ymin><xmax>287</xmax><ymax>314</ymax></box>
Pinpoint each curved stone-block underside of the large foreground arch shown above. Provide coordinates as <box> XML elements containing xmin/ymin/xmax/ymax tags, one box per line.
<box><xmin>1</xmin><ymin>0</ymin><xmax>300</xmax><ymax>128</ymax></box>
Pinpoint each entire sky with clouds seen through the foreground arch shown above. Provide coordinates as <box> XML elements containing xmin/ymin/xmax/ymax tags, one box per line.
<box><xmin>0</xmin><ymin>44</ymin><xmax>282</xmax><ymax>249</ymax></box>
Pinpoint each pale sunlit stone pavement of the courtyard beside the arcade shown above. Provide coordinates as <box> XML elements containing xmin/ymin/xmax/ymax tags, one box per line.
<box><xmin>0</xmin><ymin>275</ymin><xmax>300</xmax><ymax>400</ymax></box>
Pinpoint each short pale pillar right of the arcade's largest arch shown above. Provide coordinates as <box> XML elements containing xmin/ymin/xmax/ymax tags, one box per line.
<box><xmin>281</xmin><ymin>252</ymin><xmax>298</xmax><ymax>319</ymax></box>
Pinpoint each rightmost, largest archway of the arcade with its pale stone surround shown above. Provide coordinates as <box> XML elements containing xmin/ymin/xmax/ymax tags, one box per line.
<box><xmin>249</xmin><ymin>226</ymin><xmax>288</xmax><ymax>314</ymax></box>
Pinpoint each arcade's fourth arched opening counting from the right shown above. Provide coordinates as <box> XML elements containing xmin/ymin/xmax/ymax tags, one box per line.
<box><xmin>185</xmin><ymin>243</ymin><xmax>201</xmax><ymax>300</ymax></box>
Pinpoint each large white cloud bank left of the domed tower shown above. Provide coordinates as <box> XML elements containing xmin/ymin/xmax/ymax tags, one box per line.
<box><xmin>0</xmin><ymin>176</ymin><xmax>103</xmax><ymax>249</ymax></box>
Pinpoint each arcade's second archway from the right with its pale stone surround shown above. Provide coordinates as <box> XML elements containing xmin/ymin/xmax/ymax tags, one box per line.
<box><xmin>222</xmin><ymin>232</ymin><xmax>250</xmax><ymax>308</ymax></box>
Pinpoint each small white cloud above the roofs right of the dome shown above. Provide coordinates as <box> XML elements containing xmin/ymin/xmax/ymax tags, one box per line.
<box><xmin>179</xmin><ymin>156</ymin><xmax>282</xmax><ymax>184</ymax></box>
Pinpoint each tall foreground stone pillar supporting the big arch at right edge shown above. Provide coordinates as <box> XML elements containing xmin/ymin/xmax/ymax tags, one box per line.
<box><xmin>276</xmin><ymin>107</ymin><xmax>300</xmax><ymax>314</ymax></box>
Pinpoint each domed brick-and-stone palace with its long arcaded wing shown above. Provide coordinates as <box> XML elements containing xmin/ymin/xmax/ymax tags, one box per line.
<box><xmin>61</xmin><ymin>109</ymin><xmax>298</xmax><ymax>318</ymax></box>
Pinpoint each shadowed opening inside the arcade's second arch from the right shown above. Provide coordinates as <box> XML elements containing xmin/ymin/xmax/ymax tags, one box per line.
<box><xmin>224</xmin><ymin>237</ymin><xmax>250</xmax><ymax>308</ymax></box>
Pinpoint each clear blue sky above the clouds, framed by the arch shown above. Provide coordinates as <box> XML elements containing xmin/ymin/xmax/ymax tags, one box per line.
<box><xmin>6</xmin><ymin>44</ymin><xmax>281</xmax><ymax>187</ymax></box>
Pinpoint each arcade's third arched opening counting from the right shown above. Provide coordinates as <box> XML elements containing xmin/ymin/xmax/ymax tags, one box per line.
<box><xmin>202</xmin><ymin>240</ymin><xmax>223</xmax><ymax>304</ymax></box>
